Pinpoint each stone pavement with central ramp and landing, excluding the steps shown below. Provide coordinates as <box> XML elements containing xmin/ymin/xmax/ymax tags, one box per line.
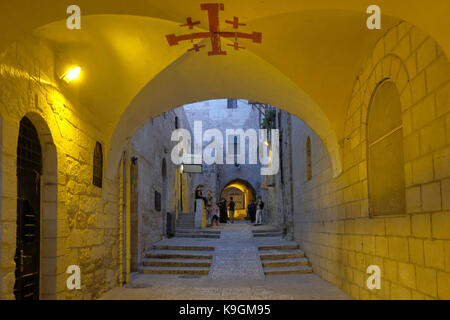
<box><xmin>101</xmin><ymin>223</ymin><xmax>350</xmax><ymax>300</ymax></box>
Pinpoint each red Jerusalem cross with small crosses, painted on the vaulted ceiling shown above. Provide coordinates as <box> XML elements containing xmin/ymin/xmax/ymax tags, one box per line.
<box><xmin>166</xmin><ymin>3</ymin><xmax>262</xmax><ymax>56</ymax></box>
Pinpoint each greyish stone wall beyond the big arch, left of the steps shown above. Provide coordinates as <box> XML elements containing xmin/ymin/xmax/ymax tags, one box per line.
<box><xmin>131</xmin><ymin>108</ymin><xmax>193</xmax><ymax>261</ymax></box>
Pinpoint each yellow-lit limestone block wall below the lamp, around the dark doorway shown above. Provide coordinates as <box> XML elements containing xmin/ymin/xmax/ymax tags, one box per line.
<box><xmin>0</xmin><ymin>36</ymin><xmax>119</xmax><ymax>299</ymax></box>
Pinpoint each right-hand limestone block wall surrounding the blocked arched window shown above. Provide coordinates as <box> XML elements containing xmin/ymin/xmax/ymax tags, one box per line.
<box><xmin>292</xmin><ymin>22</ymin><xmax>450</xmax><ymax>299</ymax></box>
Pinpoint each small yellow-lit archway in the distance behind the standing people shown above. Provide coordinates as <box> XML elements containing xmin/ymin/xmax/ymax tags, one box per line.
<box><xmin>220</xmin><ymin>179</ymin><xmax>256</xmax><ymax>220</ymax></box>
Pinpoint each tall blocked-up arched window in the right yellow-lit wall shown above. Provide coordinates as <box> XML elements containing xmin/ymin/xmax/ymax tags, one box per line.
<box><xmin>367</xmin><ymin>80</ymin><xmax>405</xmax><ymax>216</ymax></box>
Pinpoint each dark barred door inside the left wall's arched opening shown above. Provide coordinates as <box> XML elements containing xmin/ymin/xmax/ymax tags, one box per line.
<box><xmin>14</xmin><ymin>117</ymin><xmax>42</xmax><ymax>300</ymax></box>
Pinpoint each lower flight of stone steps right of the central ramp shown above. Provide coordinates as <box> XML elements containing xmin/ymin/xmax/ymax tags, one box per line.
<box><xmin>258</xmin><ymin>244</ymin><xmax>312</xmax><ymax>275</ymax></box>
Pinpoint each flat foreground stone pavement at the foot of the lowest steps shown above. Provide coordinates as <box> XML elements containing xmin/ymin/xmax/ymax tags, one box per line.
<box><xmin>101</xmin><ymin>274</ymin><xmax>350</xmax><ymax>300</ymax></box>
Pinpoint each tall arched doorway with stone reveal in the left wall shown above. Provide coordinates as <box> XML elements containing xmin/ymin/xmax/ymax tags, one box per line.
<box><xmin>14</xmin><ymin>113</ymin><xmax>58</xmax><ymax>300</ymax></box>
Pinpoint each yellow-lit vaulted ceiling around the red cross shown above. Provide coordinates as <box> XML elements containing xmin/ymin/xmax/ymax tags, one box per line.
<box><xmin>0</xmin><ymin>0</ymin><xmax>450</xmax><ymax>176</ymax></box>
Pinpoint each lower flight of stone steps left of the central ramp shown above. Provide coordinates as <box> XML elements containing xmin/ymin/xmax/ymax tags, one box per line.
<box><xmin>139</xmin><ymin>245</ymin><xmax>214</xmax><ymax>275</ymax></box>
